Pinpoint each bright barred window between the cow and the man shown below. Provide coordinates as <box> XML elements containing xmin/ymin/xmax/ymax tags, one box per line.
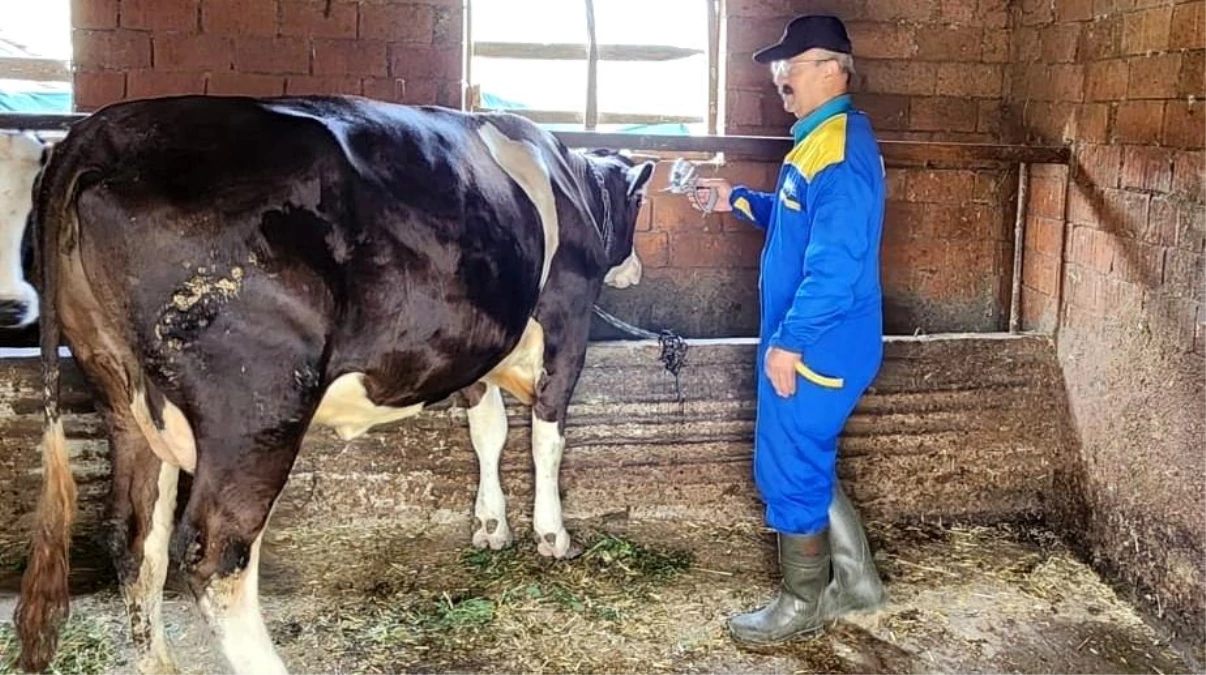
<box><xmin>467</xmin><ymin>0</ymin><xmax>720</xmax><ymax>135</ymax></box>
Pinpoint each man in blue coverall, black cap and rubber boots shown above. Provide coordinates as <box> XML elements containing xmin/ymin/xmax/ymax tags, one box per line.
<box><xmin>696</xmin><ymin>16</ymin><xmax>885</xmax><ymax>644</ymax></box>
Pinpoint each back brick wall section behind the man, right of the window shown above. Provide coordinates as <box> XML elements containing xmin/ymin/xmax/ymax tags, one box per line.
<box><xmin>602</xmin><ymin>0</ymin><xmax>1017</xmax><ymax>336</ymax></box>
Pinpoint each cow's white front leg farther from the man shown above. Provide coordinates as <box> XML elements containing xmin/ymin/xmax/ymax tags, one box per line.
<box><xmin>466</xmin><ymin>383</ymin><xmax>513</xmax><ymax>551</ymax></box>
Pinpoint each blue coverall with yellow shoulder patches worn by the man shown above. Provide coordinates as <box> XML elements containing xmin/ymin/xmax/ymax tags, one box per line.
<box><xmin>728</xmin><ymin>95</ymin><xmax>886</xmax><ymax>535</ymax></box>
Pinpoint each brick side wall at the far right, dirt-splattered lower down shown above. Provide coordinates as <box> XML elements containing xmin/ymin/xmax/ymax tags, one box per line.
<box><xmin>1008</xmin><ymin>0</ymin><xmax>1206</xmax><ymax>646</ymax></box>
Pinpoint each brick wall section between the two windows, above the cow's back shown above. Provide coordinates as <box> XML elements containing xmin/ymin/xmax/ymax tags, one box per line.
<box><xmin>72</xmin><ymin>0</ymin><xmax>462</xmax><ymax>111</ymax></box>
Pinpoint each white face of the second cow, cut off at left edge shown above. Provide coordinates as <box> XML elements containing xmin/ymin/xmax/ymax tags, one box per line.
<box><xmin>0</xmin><ymin>131</ymin><xmax>42</xmax><ymax>328</ymax></box>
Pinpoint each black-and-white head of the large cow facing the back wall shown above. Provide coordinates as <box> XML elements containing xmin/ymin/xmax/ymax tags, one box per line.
<box><xmin>586</xmin><ymin>149</ymin><xmax>655</xmax><ymax>288</ymax></box>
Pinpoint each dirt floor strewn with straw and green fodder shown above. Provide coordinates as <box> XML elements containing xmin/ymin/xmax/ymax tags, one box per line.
<box><xmin>0</xmin><ymin>523</ymin><xmax>1202</xmax><ymax>675</ymax></box>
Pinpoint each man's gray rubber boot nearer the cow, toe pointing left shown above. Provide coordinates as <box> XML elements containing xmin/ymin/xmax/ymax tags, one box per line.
<box><xmin>728</xmin><ymin>532</ymin><xmax>830</xmax><ymax>645</ymax></box>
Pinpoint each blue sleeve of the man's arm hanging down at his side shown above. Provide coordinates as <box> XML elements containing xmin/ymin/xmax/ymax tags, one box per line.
<box><xmin>771</xmin><ymin>163</ymin><xmax>873</xmax><ymax>353</ymax></box>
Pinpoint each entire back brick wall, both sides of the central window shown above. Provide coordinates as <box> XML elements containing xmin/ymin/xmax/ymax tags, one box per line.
<box><xmin>74</xmin><ymin>0</ymin><xmax>1014</xmax><ymax>336</ymax></box>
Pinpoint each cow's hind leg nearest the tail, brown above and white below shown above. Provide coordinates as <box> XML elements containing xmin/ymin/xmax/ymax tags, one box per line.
<box><xmin>109</xmin><ymin>413</ymin><xmax>180</xmax><ymax>675</ymax></box>
